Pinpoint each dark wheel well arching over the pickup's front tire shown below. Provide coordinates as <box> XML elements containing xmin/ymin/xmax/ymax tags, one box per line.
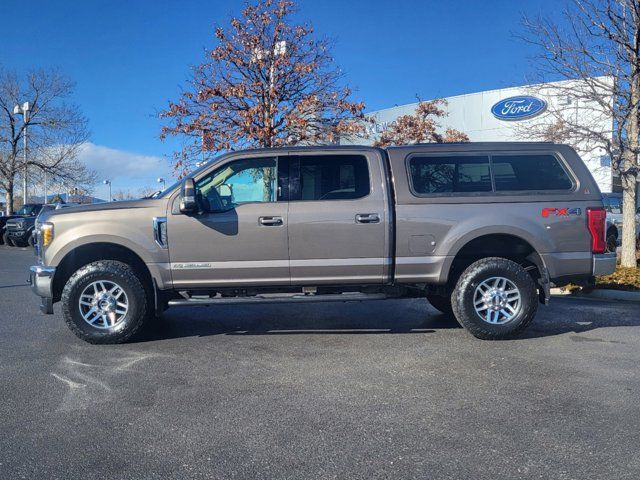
<box><xmin>53</xmin><ymin>243</ymin><xmax>153</xmax><ymax>301</ymax></box>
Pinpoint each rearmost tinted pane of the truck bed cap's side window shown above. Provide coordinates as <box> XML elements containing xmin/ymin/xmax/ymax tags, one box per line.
<box><xmin>491</xmin><ymin>154</ymin><xmax>573</xmax><ymax>192</ymax></box>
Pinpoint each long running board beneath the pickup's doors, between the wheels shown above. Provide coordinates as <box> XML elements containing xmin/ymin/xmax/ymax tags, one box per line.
<box><xmin>168</xmin><ymin>292</ymin><xmax>388</xmax><ymax>307</ymax></box>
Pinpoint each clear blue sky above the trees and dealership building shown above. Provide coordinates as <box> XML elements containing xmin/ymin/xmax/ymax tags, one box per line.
<box><xmin>0</xmin><ymin>0</ymin><xmax>563</xmax><ymax>193</ymax></box>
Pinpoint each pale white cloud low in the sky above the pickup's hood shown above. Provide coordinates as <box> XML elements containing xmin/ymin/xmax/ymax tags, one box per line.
<box><xmin>78</xmin><ymin>142</ymin><xmax>172</xmax><ymax>189</ymax></box>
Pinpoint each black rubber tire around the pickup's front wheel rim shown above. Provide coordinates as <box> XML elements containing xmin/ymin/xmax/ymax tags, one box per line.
<box><xmin>61</xmin><ymin>260</ymin><xmax>151</xmax><ymax>344</ymax></box>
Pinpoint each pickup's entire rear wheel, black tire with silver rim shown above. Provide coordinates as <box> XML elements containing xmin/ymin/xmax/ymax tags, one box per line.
<box><xmin>451</xmin><ymin>257</ymin><xmax>538</xmax><ymax>340</ymax></box>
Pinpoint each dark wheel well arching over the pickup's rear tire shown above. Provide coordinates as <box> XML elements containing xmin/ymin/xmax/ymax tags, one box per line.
<box><xmin>447</xmin><ymin>234</ymin><xmax>544</xmax><ymax>288</ymax></box>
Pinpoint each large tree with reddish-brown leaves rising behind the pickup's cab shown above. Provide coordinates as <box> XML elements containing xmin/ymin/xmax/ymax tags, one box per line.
<box><xmin>160</xmin><ymin>0</ymin><xmax>364</xmax><ymax>175</ymax></box>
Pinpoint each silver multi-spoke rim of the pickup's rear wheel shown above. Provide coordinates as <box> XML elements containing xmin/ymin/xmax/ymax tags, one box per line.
<box><xmin>473</xmin><ymin>277</ymin><xmax>522</xmax><ymax>325</ymax></box>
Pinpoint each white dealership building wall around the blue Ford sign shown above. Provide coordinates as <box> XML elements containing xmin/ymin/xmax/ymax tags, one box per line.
<box><xmin>352</xmin><ymin>80</ymin><xmax>613</xmax><ymax>192</ymax></box>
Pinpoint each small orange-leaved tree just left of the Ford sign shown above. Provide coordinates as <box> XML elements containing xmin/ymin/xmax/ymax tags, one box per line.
<box><xmin>375</xmin><ymin>99</ymin><xmax>469</xmax><ymax>147</ymax></box>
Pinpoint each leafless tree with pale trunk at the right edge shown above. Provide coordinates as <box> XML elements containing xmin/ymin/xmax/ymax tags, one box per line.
<box><xmin>523</xmin><ymin>0</ymin><xmax>640</xmax><ymax>267</ymax></box>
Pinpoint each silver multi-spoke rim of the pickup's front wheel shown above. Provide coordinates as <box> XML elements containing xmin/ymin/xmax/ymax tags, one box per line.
<box><xmin>78</xmin><ymin>280</ymin><xmax>129</xmax><ymax>329</ymax></box>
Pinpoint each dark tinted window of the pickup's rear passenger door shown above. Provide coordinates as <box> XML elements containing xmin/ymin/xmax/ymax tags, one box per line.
<box><xmin>292</xmin><ymin>155</ymin><xmax>370</xmax><ymax>200</ymax></box>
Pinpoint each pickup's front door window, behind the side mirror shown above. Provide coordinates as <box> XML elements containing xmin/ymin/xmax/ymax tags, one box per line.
<box><xmin>196</xmin><ymin>157</ymin><xmax>278</xmax><ymax>212</ymax></box>
